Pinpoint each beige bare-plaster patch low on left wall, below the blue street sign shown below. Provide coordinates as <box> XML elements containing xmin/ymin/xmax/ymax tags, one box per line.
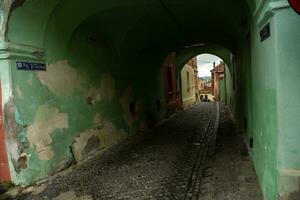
<box><xmin>28</xmin><ymin>104</ymin><xmax>68</xmax><ymax>160</ymax></box>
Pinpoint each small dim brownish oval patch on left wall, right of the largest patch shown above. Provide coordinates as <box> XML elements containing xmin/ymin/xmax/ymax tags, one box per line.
<box><xmin>100</xmin><ymin>74</ymin><xmax>115</xmax><ymax>100</ymax></box>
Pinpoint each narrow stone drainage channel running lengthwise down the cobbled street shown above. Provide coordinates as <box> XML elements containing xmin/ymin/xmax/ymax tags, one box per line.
<box><xmin>184</xmin><ymin>103</ymin><xmax>220</xmax><ymax>200</ymax></box>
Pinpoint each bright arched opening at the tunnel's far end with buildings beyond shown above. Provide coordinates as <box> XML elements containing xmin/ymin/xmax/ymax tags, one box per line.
<box><xmin>179</xmin><ymin>53</ymin><xmax>235</xmax><ymax>109</ymax></box>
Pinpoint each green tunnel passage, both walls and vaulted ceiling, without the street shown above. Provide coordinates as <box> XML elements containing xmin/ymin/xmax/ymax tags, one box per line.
<box><xmin>0</xmin><ymin>0</ymin><xmax>300</xmax><ymax>199</ymax></box>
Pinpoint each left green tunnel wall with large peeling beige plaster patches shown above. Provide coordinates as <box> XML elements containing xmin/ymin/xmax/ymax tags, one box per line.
<box><xmin>4</xmin><ymin>1</ymin><xmax>164</xmax><ymax>185</ymax></box>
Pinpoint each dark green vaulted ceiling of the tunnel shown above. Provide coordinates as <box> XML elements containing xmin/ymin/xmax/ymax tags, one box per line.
<box><xmin>9</xmin><ymin>0</ymin><xmax>253</xmax><ymax>62</ymax></box>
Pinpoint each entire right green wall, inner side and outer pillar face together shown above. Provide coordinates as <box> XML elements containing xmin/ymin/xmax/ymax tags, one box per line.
<box><xmin>235</xmin><ymin>1</ymin><xmax>300</xmax><ymax>200</ymax></box>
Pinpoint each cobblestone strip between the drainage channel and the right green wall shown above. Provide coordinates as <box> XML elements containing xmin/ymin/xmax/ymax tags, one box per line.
<box><xmin>201</xmin><ymin>106</ymin><xmax>263</xmax><ymax>200</ymax></box>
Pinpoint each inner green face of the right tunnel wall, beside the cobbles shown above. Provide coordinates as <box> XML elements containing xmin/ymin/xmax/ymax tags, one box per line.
<box><xmin>243</xmin><ymin>16</ymin><xmax>278</xmax><ymax>200</ymax></box>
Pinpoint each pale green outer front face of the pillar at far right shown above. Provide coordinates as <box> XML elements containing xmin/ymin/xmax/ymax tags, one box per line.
<box><xmin>274</xmin><ymin>9</ymin><xmax>300</xmax><ymax>199</ymax></box>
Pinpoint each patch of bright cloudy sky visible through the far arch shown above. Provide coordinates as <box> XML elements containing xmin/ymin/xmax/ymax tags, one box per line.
<box><xmin>197</xmin><ymin>54</ymin><xmax>222</xmax><ymax>77</ymax></box>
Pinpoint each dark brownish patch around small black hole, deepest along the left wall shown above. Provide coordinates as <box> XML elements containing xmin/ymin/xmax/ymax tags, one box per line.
<box><xmin>120</xmin><ymin>87</ymin><xmax>143</xmax><ymax>126</ymax></box>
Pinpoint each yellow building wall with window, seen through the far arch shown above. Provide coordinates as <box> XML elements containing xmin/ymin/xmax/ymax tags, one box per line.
<box><xmin>181</xmin><ymin>64</ymin><xmax>196</xmax><ymax>109</ymax></box>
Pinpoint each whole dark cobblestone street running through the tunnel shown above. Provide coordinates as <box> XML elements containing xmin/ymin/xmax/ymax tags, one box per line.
<box><xmin>10</xmin><ymin>103</ymin><xmax>262</xmax><ymax>200</ymax></box>
